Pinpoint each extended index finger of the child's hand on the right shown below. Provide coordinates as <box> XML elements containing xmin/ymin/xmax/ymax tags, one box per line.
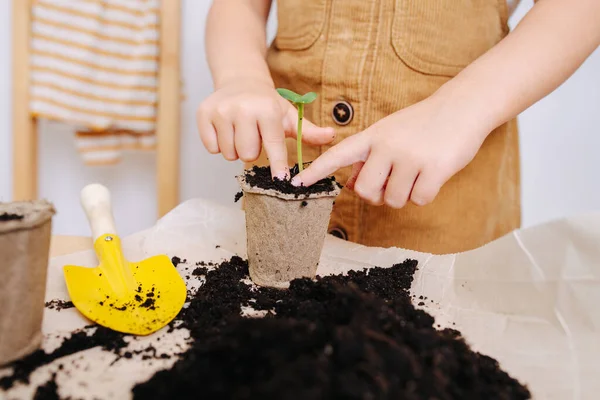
<box><xmin>292</xmin><ymin>134</ymin><xmax>369</xmax><ymax>186</ymax></box>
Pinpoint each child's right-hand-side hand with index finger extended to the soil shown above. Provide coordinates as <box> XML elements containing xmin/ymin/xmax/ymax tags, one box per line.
<box><xmin>292</xmin><ymin>97</ymin><xmax>489</xmax><ymax>208</ymax></box>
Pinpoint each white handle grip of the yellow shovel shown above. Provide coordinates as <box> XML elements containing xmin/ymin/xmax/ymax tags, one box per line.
<box><xmin>81</xmin><ymin>183</ymin><xmax>117</xmax><ymax>242</ymax></box>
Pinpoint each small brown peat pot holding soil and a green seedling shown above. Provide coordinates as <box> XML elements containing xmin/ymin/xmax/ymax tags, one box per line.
<box><xmin>238</xmin><ymin>89</ymin><xmax>341</xmax><ymax>289</ymax></box>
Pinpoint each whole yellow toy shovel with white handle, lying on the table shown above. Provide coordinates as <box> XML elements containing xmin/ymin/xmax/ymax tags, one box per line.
<box><xmin>64</xmin><ymin>184</ymin><xmax>187</xmax><ymax>335</ymax></box>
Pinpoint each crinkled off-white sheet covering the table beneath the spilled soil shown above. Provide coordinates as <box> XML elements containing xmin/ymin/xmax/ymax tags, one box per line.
<box><xmin>0</xmin><ymin>200</ymin><xmax>600</xmax><ymax>400</ymax></box>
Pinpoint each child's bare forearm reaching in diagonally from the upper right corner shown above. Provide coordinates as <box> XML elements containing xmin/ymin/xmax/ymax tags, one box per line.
<box><xmin>436</xmin><ymin>0</ymin><xmax>600</xmax><ymax>135</ymax></box>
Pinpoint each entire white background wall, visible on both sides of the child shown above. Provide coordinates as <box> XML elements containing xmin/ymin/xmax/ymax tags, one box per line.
<box><xmin>0</xmin><ymin>0</ymin><xmax>600</xmax><ymax>235</ymax></box>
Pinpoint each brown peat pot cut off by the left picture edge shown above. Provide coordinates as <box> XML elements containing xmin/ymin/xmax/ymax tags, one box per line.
<box><xmin>0</xmin><ymin>200</ymin><xmax>55</xmax><ymax>365</ymax></box>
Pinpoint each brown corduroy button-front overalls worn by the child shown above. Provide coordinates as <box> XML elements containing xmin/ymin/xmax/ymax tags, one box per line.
<box><xmin>248</xmin><ymin>0</ymin><xmax>520</xmax><ymax>254</ymax></box>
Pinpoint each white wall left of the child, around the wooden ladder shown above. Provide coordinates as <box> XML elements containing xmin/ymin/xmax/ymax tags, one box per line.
<box><xmin>0</xmin><ymin>0</ymin><xmax>275</xmax><ymax>235</ymax></box>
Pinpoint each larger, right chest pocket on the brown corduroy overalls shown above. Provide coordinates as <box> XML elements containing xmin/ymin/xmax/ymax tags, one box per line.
<box><xmin>391</xmin><ymin>0</ymin><xmax>508</xmax><ymax>77</ymax></box>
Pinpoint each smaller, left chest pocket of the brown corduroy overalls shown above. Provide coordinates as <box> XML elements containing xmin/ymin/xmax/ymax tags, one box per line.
<box><xmin>273</xmin><ymin>0</ymin><xmax>327</xmax><ymax>50</ymax></box>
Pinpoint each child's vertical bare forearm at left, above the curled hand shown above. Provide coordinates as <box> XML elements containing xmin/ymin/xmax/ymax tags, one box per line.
<box><xmin>206</xmin><ymin>0</ymin><xmax>272</xmax><ymax>89</ymax></box>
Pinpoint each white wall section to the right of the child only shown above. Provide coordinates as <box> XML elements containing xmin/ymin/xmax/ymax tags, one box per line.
<box><xmin>511</xmin><ymin>0</ymin><xmax>600</xmax><ymax>226</ymax></box>
